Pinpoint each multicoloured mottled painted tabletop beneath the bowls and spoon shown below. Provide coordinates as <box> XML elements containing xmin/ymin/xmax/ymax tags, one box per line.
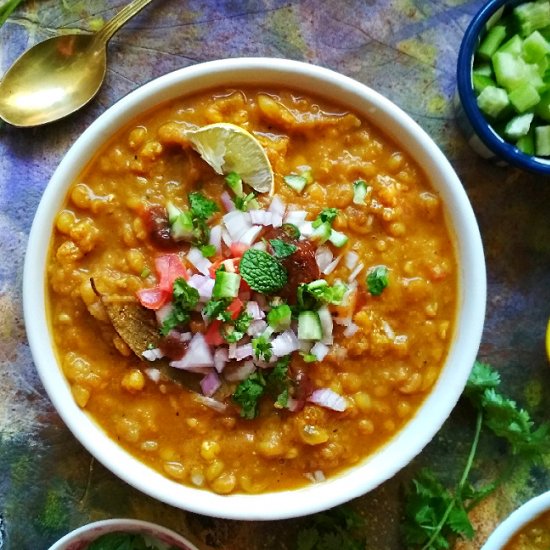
<box><xmin>0</xmin><ymin>0</ymin><xmax>550</xmax><ymax>550</ymax></box>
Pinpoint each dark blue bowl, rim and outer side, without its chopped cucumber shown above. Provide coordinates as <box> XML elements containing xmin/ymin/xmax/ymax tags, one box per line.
<box><xmin>456</xmin><ymin>0</ymin><xmax>550</xmax><ymax>175</ymax></box>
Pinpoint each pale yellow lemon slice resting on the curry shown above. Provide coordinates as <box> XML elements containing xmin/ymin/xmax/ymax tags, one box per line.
<box><xmin>185</xmin><ymin>122</ymin><xmax>274</xmax><ymax>193</ymax></box>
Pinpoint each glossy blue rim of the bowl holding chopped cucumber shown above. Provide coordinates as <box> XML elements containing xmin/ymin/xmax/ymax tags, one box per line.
<box><xmin>456</xmin><ymin>0</ymin><xmax>550</xmax><ymax>175</ymax></box>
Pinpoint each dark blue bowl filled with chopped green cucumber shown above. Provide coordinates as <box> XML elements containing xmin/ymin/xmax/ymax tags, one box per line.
<box><xmin>457</xmin><ymin>0</ymin><xmax>550</xmax><ymax>175</ymax></box>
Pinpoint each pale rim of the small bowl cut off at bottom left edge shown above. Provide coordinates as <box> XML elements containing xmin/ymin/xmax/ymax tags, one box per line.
<box><xmin>49</xmin><ymin>519</ymin><xmax>198</xmax><ymax>550</ymax></box>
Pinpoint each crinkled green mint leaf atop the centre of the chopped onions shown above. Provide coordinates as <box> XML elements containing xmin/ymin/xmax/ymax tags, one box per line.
<box><xmin>239</xmin><ymin>248</ymin><xmax>288</xmax><ymax>294</ymax></box>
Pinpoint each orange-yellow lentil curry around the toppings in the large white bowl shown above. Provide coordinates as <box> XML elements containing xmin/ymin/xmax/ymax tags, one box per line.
<box><xmin>47</xmin><ymin>87</ymin><xmax>458</xmax><ymax>494</ymax></box>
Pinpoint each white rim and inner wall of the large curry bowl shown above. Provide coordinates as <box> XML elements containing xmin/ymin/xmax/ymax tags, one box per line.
<box><xmin>23</xmin><ymin>58</ymin><xmax>486</xmax><ymax>520</ymax></box>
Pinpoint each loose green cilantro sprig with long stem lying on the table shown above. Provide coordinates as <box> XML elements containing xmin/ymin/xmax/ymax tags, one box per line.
<box><xmin>404</xmin><ymin>361</ymin><xmax>550</xmax><ymax>550</ymax></box>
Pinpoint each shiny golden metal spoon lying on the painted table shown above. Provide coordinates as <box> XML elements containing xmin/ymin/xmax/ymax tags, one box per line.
<box><xmin>0</xmin><ymin>0</ymin><xmax>151</xmax><ymax>127</ymax></box>
